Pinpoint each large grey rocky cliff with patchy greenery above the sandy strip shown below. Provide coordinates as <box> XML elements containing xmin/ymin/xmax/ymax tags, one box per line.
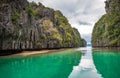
<box><xmin>0</xmin><ymin>0</ymin><xmax>86</xmax><ymax>50</ymax></box>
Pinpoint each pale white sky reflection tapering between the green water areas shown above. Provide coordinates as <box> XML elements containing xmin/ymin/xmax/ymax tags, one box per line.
<box><xmin>69</xmin><ymin>47</ymin><xmax>102</xmax><ymax>78</ymax></box>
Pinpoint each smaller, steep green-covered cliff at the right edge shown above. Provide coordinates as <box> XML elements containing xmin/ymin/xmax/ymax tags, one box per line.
<box><xmin>92</xmin><ymin>0</ymin><xmax>120</xmax><ymax>47</ymax></box>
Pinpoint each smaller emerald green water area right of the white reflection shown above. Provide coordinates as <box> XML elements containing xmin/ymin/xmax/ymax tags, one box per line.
<box><xmin>93</xmin><ymin>50</ymin><xmax>120</xmax><ymax>78</ymax></box>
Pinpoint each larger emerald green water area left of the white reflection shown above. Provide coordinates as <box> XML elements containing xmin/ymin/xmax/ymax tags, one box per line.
<box><xmin>0</xmin><ymin>50</ymin><xmax>81</xmax><ymax>78</ymax></box>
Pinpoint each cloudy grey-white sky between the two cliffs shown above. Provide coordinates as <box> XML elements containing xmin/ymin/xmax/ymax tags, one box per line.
<box><xmin>28</xmin><ymin>0</ymin><xmax>105</xmax><ymax>43</ymax></box>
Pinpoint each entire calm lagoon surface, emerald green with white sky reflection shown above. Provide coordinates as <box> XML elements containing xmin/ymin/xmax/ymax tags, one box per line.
<box><xmin>0</xmin><ymin>47</ymin><xmax>120</xmax><ymax>78</ymax></box>
